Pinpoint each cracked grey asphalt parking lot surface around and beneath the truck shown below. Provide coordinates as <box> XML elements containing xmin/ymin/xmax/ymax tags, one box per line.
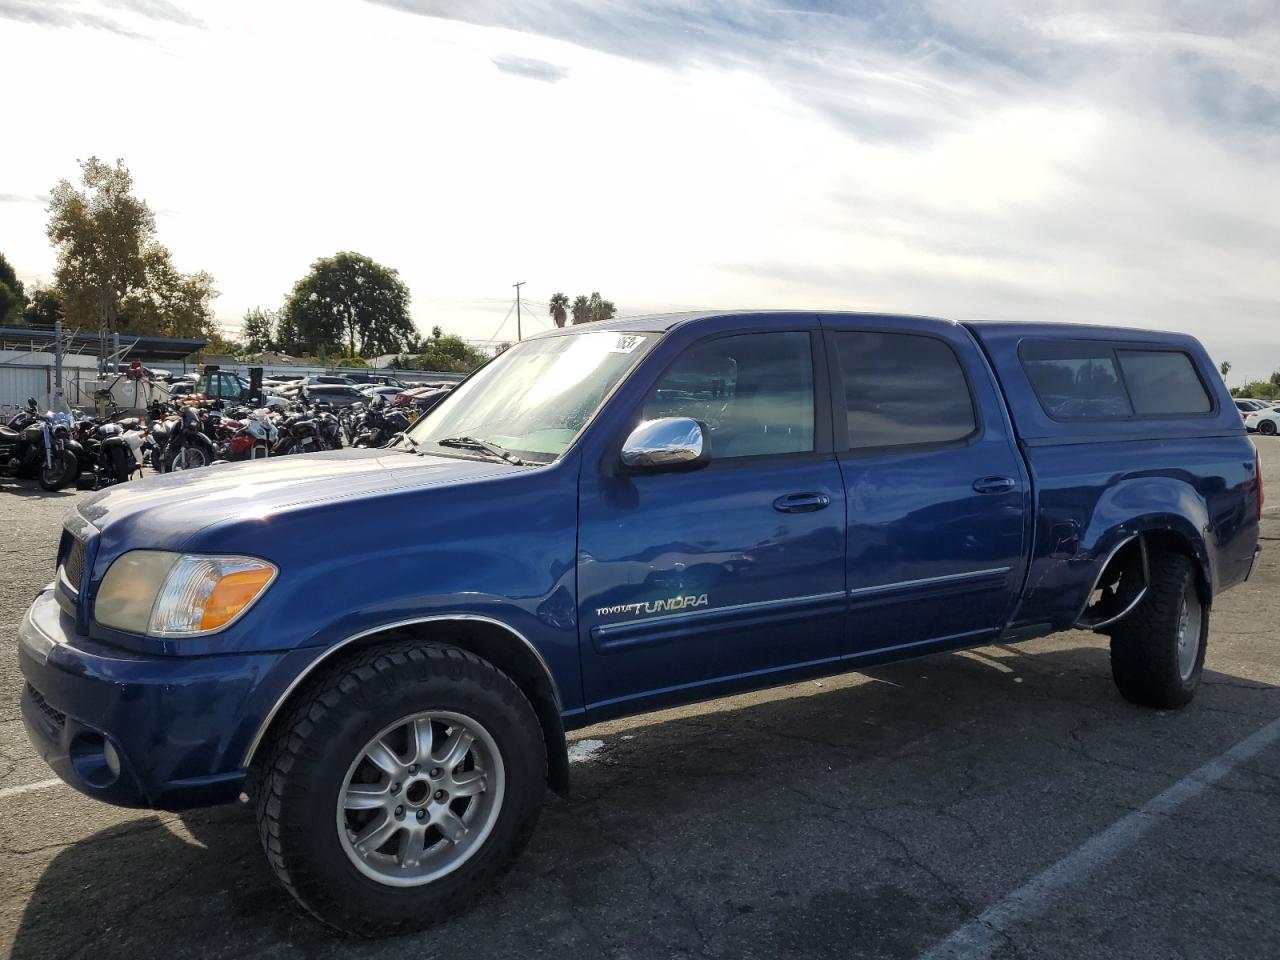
<box><xmin>0</xmin><ymin>438</ymin><xmax>1280</xmax><ymax>960</ymax></box>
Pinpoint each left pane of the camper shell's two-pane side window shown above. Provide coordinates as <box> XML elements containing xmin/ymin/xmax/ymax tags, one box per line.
<box><xmin>1019</xmin><ymin>340</ymin><xmax>1133</xmax><ymax>420</ymax></box>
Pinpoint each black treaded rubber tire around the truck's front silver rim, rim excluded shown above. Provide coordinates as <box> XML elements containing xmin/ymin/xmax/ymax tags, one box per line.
<box><xmin>256</xmin><ymin>641</ymin><xmax>547</xmax><ymax>937</ymax></box>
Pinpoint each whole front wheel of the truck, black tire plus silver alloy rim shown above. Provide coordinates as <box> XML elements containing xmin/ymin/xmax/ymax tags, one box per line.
<box><xmin>257</xmin><ymin>641</ymin><xmax>547</xmax><ymax>937</ymax></box>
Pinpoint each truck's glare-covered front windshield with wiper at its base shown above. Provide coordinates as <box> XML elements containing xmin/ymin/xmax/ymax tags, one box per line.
<box><xmin>410</xmin><ymin>330</ymin><xmax>654</xmax><ymax>463</ymax></box>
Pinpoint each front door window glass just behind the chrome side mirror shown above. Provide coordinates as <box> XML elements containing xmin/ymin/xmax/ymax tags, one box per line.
<box><xmin>644</xmin><ymin>333</ymin><xmax>814</xmax><ymax>460</ymax></box>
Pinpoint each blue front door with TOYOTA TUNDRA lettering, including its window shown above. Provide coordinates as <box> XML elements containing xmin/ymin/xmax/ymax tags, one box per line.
<box><xmin>579</xmin><ymin>323</ymin><xmax>845</xmax><ymax>718</ymax></box>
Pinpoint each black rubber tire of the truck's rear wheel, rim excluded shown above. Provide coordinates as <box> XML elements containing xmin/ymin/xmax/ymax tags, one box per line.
<box><xmin>1107</xmin><ymin>553</ymin><xmax>1210</xmax><ymax>709</ymax></box>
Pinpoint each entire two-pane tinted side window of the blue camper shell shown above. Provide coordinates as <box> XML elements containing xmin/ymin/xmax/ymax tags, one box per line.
<box><xmin>1019</xmin><ymin>340</ymin><xmax>1213</xmax><ymax>420</ymax></box>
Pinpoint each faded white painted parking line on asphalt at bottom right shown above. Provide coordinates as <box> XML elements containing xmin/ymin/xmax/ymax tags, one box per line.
<box><xmin>919</xmin><ymin>719</ymin><xmax>1280</xmax><ymax>960</ymax></box>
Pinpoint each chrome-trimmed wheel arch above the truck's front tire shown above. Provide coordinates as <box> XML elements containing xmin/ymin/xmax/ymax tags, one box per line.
<box><xmin>242</xmin><ymin>613</ymin><xmax>570</xmax><ymax>795</ymax></box>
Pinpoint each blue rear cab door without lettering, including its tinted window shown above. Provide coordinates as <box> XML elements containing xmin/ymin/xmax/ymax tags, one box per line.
<box><xmin>823</xmin><ymin>316</ymin><xmax>1029</xmax><ymax>654</ymax></box>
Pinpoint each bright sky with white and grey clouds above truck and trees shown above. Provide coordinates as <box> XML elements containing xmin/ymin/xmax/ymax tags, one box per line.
<box><xmin>0</xmin><ymin>0</ymin><xmax>1280</xmax><ymax>381</ymax></box>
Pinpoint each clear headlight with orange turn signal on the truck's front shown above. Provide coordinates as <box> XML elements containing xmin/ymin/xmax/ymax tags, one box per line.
<box><xmin>93</xmin><ymin>550</ymin><xmax>276</xmax><ymax>636</ymax></box>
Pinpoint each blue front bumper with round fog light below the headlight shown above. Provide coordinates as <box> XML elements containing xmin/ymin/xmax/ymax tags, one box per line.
<box><xmin>18</xmin><ymin>590</ymin><xmax>298</xmax><ymax>810</ymax></box>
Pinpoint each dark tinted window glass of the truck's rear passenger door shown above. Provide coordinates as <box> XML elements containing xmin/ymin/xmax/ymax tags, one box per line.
<box><xmin>835</xmin><ymin>332</ymin><xmax>977</xmax><ymax>449</ymax></box>
